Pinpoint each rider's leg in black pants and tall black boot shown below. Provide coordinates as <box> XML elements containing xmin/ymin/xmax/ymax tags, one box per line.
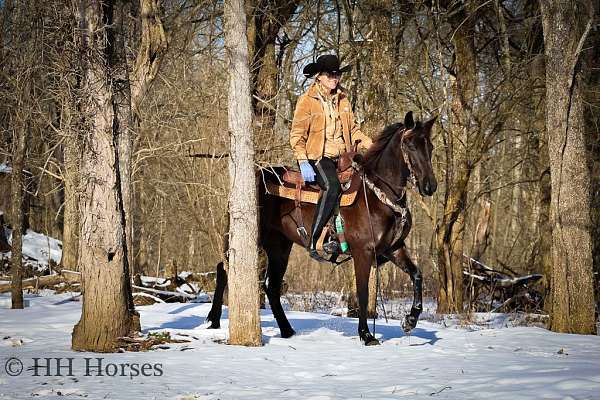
<box><xmin>308</xmin><ymin>157</ymin><xmax>342</xmax><ymax>261</ymax></box>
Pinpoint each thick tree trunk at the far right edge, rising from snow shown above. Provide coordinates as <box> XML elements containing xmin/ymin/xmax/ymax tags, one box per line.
<box><xmin>541</xmin><ymin>0</ymin><xmax>596</xmax><ymax>334</ymax></box>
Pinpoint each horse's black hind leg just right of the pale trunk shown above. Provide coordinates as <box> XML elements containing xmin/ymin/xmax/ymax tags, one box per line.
<box><xmin>263</xmin><ymin>233</ymin><xmax>296</xmax><ymax>338</ymax></box>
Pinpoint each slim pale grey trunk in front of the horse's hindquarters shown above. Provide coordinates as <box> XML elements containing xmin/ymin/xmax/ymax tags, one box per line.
<box><xmin>224</xmin><ymin>0</ymin><xmax>261</xmax><ymax>346</ymax></box>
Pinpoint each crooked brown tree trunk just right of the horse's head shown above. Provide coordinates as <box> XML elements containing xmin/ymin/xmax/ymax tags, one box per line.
<box><xmin>436</xmin><ymin>2</ymin><xmax>478</xmax><ymax>313</ymax></box>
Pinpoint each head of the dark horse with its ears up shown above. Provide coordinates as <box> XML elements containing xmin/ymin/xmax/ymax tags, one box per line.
<box><xmin>400</xmin><ymin>111</ymin><xmax>437</xmax><ymax>196</ymax></box>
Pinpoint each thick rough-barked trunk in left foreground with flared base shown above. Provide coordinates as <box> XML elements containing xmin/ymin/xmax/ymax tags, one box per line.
<box><xmin>72</xmin><ymin>0</ymin><xmax>138</xmax><ymax>352</ymax></box>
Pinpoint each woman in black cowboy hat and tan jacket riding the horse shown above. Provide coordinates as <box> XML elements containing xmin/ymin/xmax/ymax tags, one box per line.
<box><xmin>290</xmin><ymin>55</ymin><xmax>372</xmax><ymax>261</ymax></box>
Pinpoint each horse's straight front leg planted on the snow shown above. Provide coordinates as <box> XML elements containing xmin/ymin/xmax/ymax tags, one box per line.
<box><xmin>354</xmin><ymin>252</ymin><xmax>379</xmax><ymax>346</ymax></box>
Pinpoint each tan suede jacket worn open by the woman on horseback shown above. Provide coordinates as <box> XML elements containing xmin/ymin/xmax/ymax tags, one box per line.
<box><xmin>290</xmin><ymin>83</ymin><xmax>372</xmax><ymax>161</ymax></box>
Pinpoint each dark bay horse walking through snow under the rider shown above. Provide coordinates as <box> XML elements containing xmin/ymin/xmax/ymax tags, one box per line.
<box><xmin>207</xmin><ymin>112</ymin><xmax>437</xmax><ymax>345</ymax></box>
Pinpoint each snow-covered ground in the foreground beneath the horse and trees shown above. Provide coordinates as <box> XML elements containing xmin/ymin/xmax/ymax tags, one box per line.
<box><xmin>0</xmin><ymin>294</ymin><xmax>600</xmax><ymax>400</ymax></box>
